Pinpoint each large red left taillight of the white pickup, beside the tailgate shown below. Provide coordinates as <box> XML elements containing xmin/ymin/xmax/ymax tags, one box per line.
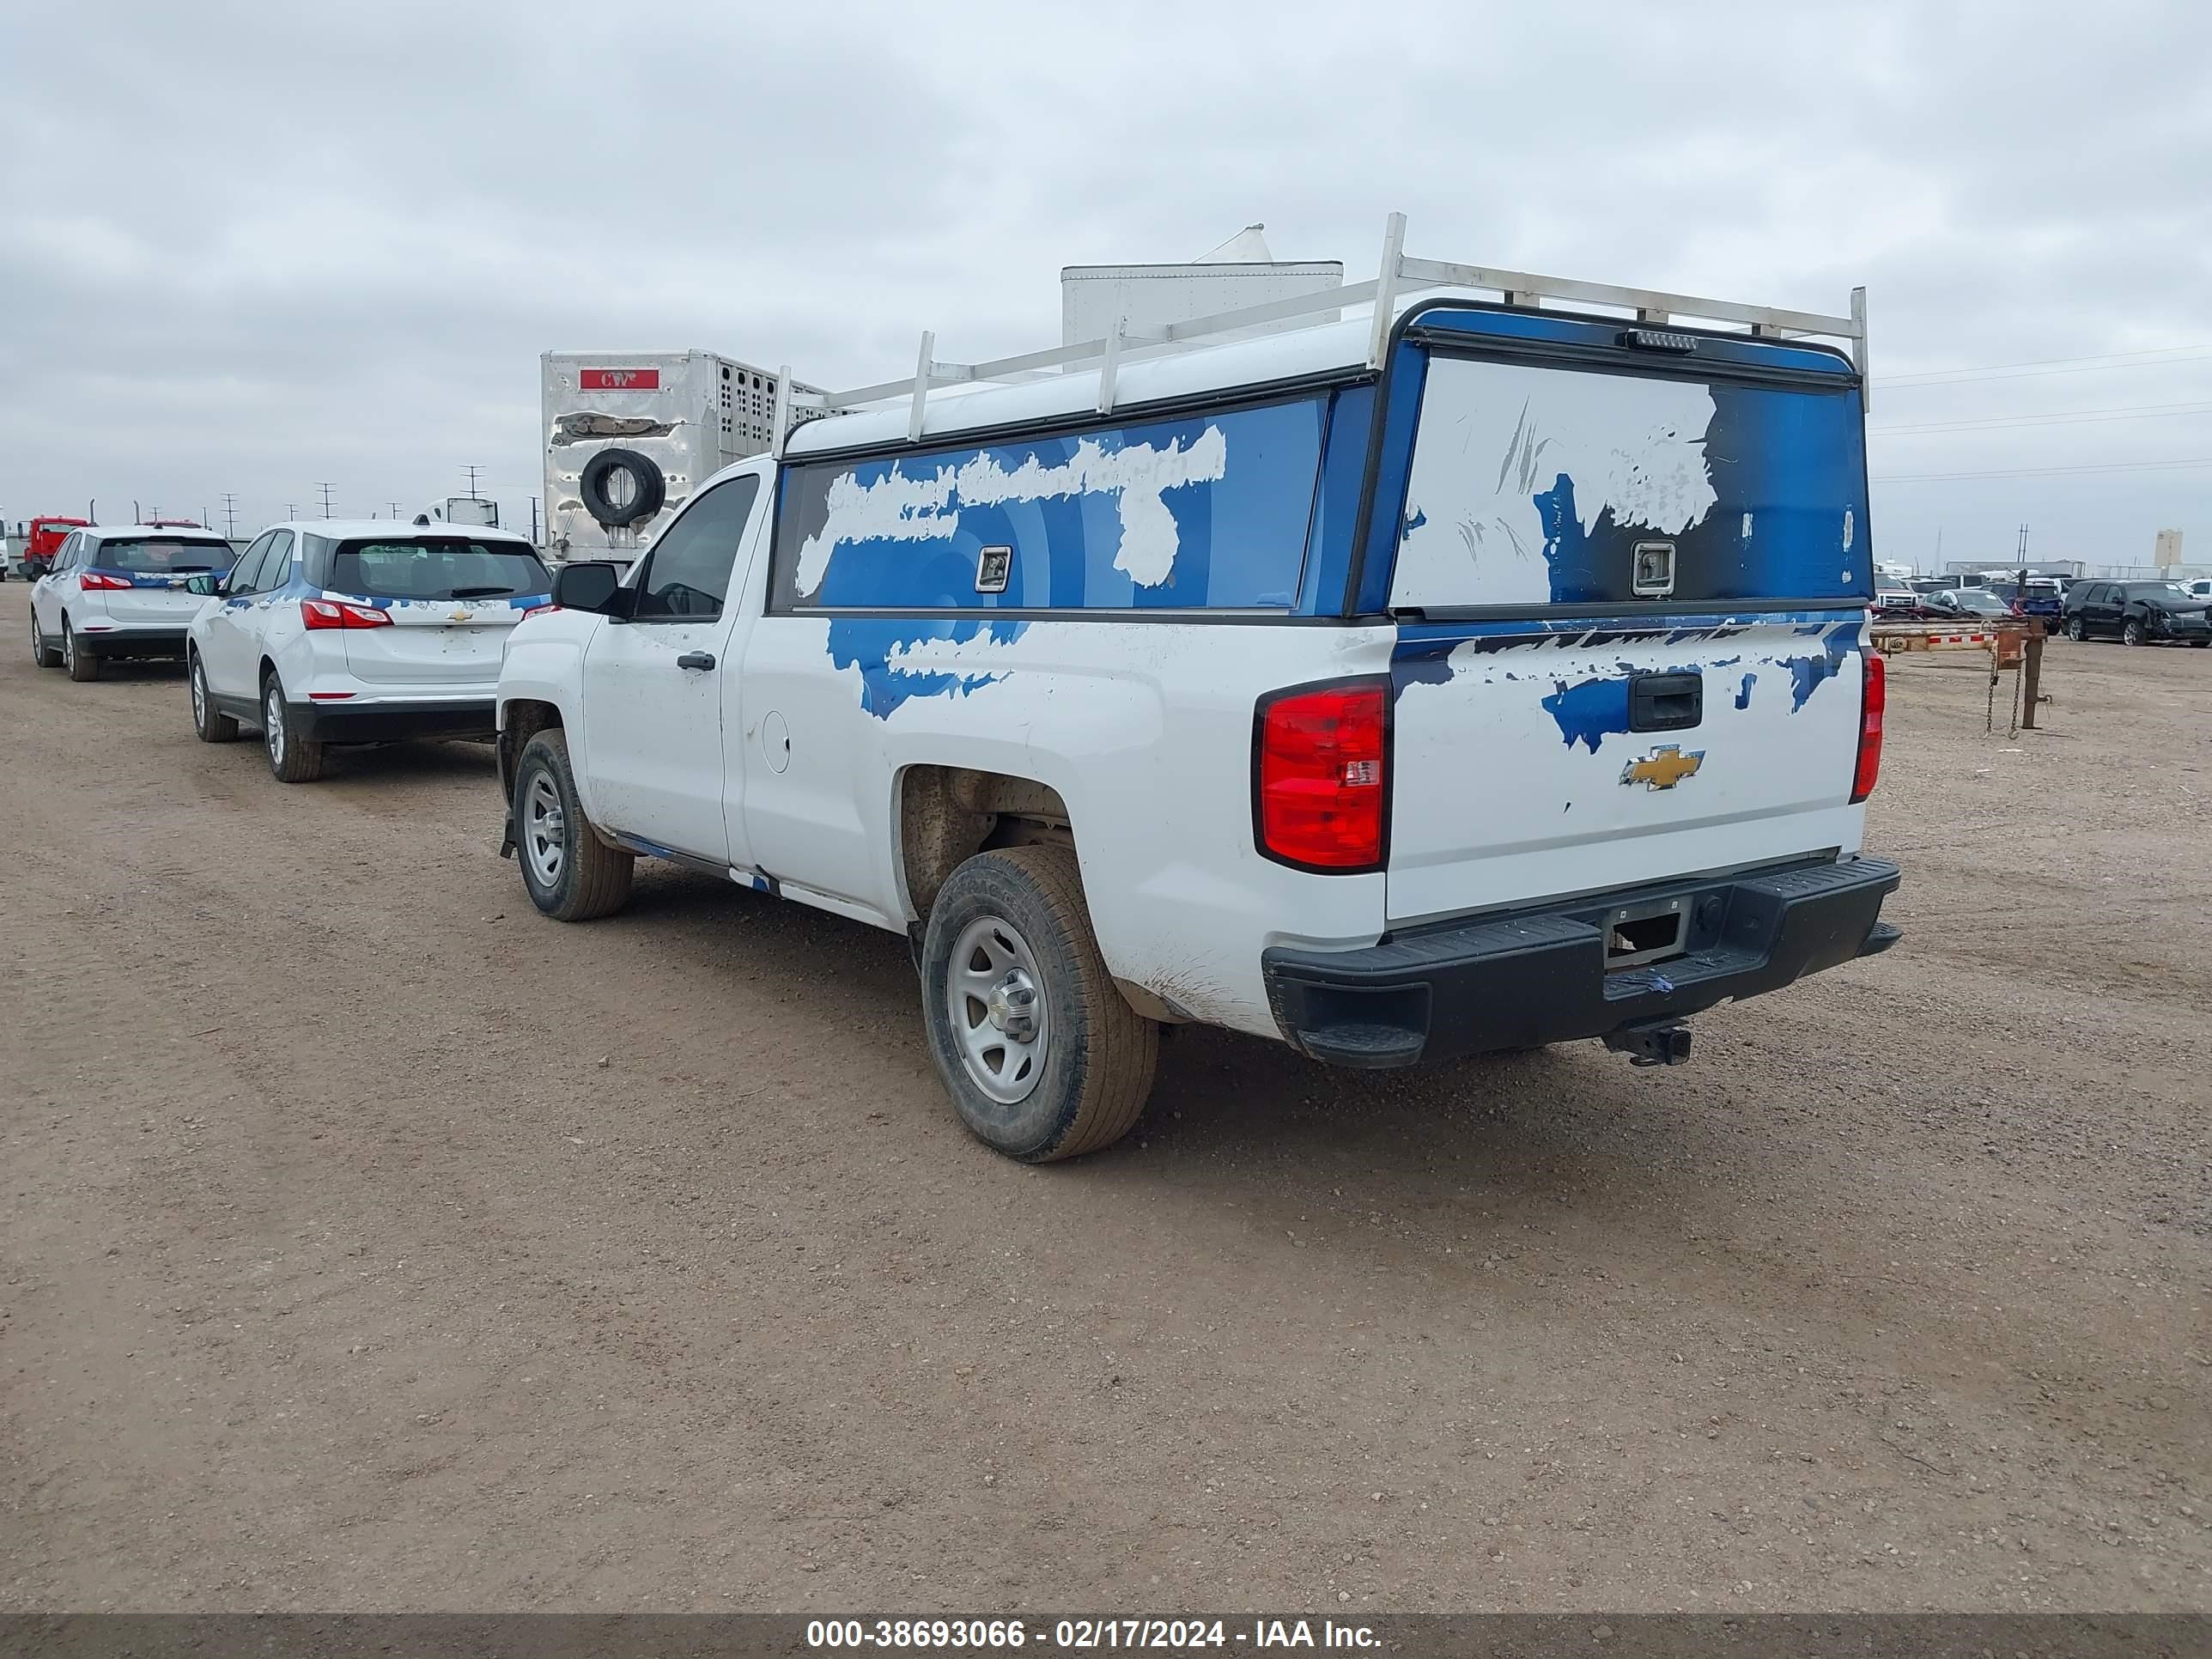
<box><xmin>1252</xmin><ymin>679</ymin><xmax>1389</xmax><ymax>874</ymax></box>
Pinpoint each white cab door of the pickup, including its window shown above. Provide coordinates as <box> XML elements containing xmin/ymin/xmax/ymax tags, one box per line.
<box><xmin>584</xmin><ymin>462</ymin><xmax>768</xmax><ymax>869</ymax></box>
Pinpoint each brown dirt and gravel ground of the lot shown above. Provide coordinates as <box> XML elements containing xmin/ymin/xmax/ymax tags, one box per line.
<box><xmin>0</xmin><ymin>581</ymin><xmax>2212</xmax><ymax>1613</ymax></box>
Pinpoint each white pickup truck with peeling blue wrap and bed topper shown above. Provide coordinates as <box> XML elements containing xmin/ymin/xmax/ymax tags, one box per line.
<box><xmin>498</xmin><ymin>237</ymin><xmax>1898</xmax><ymax>1161</ymax></box>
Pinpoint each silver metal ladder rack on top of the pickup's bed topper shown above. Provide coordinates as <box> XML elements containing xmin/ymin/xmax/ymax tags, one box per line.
<box><xmin>805</xmin><ymin>212</ymin><xmax>1867</xmax><ymax>442</ymax></box>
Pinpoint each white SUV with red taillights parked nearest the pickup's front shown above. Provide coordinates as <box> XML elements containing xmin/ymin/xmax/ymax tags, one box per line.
<box><xmin>185</xmin><ymin>520</ymin><xmax>553</xmax><ymax>783</ymax></box>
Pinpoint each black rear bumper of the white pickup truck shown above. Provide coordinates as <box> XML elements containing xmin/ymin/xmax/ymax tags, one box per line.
<box><xmin>1261</xmin><ymin>858</ymin><xmax>1900</xmax><ymax>1066</ymax></box>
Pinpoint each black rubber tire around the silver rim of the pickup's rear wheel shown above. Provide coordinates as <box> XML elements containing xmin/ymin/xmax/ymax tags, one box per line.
<box><xmin>922</xmin><ymin>848</ymin><xmax>1159</xmax><ymax>1164</ymax></box>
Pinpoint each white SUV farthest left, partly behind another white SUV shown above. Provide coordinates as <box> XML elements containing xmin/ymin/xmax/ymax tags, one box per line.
<box><xmin>31</xmin><ymin>525</ymin><xmax>230</xmax><ymax>679</ymax></box>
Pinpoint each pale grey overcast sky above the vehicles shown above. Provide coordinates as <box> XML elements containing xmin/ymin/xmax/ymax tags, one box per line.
<box><xmin>0</xmin><ymin>0</ymin><xmax>2212</xmax><ymax>568</ymax></box>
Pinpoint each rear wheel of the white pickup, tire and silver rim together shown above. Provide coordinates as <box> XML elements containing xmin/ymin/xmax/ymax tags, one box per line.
<box><xmin>922</xmin><ymin>845</ymin><xmax>1159</xmax><ymax>1164</ymax></box>
